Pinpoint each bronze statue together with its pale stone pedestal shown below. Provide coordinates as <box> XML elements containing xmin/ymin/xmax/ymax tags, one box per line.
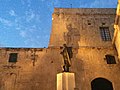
<box><xmin>57</xmin><ymin>44</ymin><xmax>75</xmax><ymax>90</ymax></box>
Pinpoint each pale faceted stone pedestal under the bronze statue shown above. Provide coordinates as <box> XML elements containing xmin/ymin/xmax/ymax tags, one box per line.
<box><xmin>57</xmin><ymin>72</ymin><xmax>75</xmax><ymax>90</ymax></box>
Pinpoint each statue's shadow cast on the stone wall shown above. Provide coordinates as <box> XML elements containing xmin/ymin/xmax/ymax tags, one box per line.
<box><xmin>64</xmin><ymin>24</ymin><xmax>80</xmax><ymax>57</ymax></box>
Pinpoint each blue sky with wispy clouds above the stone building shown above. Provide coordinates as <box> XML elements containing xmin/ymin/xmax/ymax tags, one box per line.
<box><xmin>0</xmin><ymin>0</ymin><xmax>117</xmax><ymax>48</ymax></box>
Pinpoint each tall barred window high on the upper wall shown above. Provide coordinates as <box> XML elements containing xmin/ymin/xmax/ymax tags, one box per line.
<box><xmin>100</xmin><ymin>27</ymin><xmax>111</xmax><ymax>41</ymax></box>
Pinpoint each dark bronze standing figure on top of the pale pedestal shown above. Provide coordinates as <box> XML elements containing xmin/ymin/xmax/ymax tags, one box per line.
<box><xmin>60</xmin><ymin>44</ymin><xmax>73</xmax><ymax>72</ymax></box>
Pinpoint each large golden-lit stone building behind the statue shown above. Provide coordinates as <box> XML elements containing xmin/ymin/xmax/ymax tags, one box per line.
<box><xmin>0</xmin><ymin>8</ymin><xmax>120</xmax><ymax>90</ymax></box>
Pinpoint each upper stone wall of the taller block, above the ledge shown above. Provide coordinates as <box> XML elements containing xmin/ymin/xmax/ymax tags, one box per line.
<box><xmin>49</xmin><ymin>8</ymin><xmax>115</xmax><ymax>47</ymax></box>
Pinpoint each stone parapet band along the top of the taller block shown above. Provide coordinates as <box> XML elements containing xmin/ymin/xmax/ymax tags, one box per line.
<box><xmin>53</xmin><ymin>8</ymin><xmax>116</xmax><ymax>15</ymax></box>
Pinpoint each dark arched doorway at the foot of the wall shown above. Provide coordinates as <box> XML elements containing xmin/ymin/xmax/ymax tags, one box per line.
<box><xmin>91</xmin><ymin>78</ymin><xmax>113</xmax><ymax>90</ymax></box>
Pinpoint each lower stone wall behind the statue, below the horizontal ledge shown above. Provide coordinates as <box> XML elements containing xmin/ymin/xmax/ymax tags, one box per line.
<box><xmin>0</xmin><ymin>47</ymin><xmax>120</xmax><ymax>90</ymax></box>
